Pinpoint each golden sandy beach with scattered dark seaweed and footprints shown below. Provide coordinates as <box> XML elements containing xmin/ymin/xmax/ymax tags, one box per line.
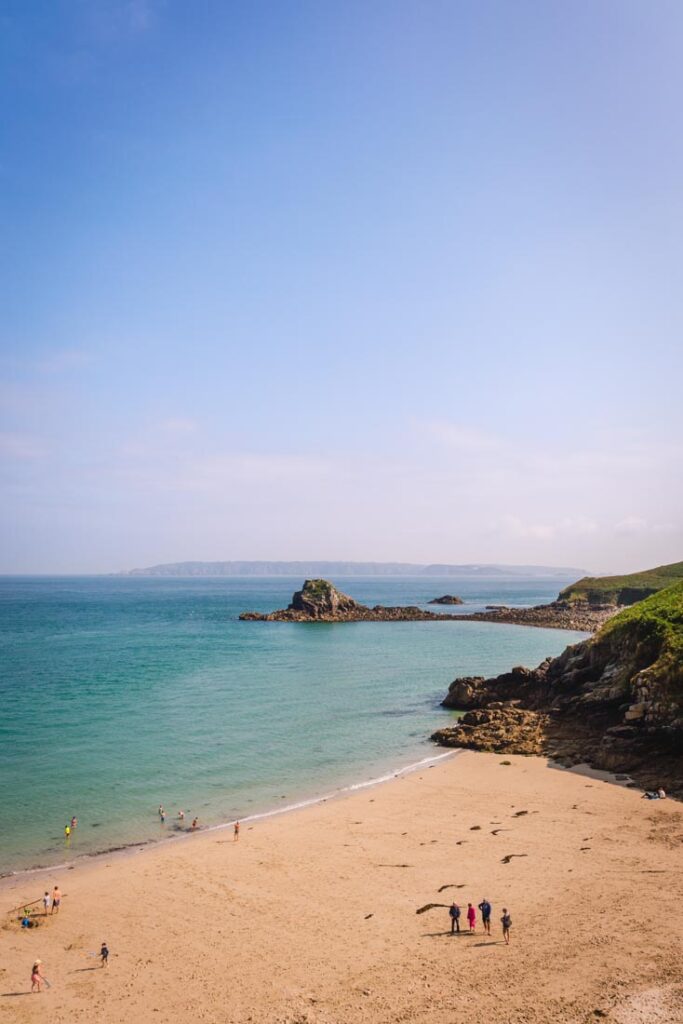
<box><xmin>0</xmin><ymin>753</ymin><xmax>683</xmax><ymax>1024</ymax></box>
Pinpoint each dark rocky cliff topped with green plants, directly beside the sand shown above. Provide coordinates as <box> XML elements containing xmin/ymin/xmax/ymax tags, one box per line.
<box><xmin>432</xmin><ymin>582</ymin><xmax>683</xmax><ymax>793</ymax></box>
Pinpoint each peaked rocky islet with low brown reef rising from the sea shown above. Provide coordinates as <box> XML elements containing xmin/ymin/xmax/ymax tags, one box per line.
<box><xmin>240</xmin><ymin>580</ymin><xmax>453</xmax><ymax>623</ymax></box>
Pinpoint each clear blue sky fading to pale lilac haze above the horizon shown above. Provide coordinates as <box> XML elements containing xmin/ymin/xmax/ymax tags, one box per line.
<box><xmin>0</xmin><ymin>0</ymin><xmax>683</xmax><ymax>571</ymax></box>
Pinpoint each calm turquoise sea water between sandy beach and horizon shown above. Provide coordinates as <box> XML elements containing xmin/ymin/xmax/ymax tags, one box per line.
<box><xmin>0</xmin><ymin>578</ymin><xmax>584</xmax><ymax>872</ymax></box>
